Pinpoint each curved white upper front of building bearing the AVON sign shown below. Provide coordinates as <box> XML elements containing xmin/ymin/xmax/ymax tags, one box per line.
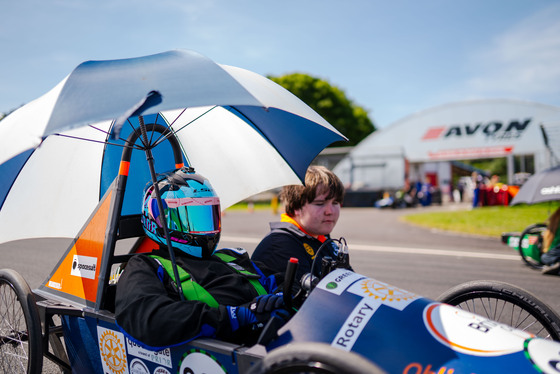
<box><xmin>342</xmin><ymin>99</ymin><xmax>560</xmax><ymax>162</ymax></box>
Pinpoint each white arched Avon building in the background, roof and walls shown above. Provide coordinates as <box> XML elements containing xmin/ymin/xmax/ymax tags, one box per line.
<box><xmin>334</xmin><ymin>99</ymin><xmax>560</xmax><ymax>194</ymax></box>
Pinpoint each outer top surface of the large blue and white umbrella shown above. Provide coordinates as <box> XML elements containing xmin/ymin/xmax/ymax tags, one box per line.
<box><xmin>0</xmin><ymin>50</ymin><xmax>334</xmax><ymax>163</ymax></box>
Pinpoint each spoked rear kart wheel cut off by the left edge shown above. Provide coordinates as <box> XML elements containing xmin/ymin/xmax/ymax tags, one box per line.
<box><xmin>0</xmin><ymin>269</ymin><xmax>43</xmax><ymax>373</ymax></box>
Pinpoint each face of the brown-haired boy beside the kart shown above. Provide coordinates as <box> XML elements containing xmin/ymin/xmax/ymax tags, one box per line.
<box><xmin>294</xmin><ymin>191</ymin><xmax>340</xmax><ymax>237</ymax></box>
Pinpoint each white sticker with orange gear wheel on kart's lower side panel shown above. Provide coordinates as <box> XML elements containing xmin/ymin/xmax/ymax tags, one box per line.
<box><xmin>97</xmin><ymin>326</ymin><xmax>128</xmax><ymax>374</ymax></box>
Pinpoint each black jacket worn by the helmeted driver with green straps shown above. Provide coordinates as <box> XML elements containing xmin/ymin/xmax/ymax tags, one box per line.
<box><xmin>115</xmin><ymin>249</ymin><xmax>276</xmax><ymax>348</ymax></box>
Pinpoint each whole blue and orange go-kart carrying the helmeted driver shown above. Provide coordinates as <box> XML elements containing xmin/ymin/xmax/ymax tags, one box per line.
<box><xmin>0</xmin><ymin>125</ymin><xmax>560</xmax><ymax>374</ymax></box>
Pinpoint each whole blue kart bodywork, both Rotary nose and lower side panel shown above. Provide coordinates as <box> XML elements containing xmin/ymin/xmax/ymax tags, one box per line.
<box><xmin>54</xmin><ymin>269</ymin><xmax>560</xmax><ymax>374</ymax></box>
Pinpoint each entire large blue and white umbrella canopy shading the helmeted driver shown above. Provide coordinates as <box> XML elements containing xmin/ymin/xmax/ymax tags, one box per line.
<box><xmin>0</xmin><ymin>51</ymin><xmax>345</xmax><ymax>242</ymax></box>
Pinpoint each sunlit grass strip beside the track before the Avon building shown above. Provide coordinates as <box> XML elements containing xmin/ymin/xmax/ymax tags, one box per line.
<box><xmin>402</xmin><ymin>202</ymin><xmax>560</xmax><ymax>237</ymax></box>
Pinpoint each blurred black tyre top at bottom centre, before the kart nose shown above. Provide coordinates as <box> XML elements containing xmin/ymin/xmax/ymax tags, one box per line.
<box><xmin>252</xmin><ymin>343</ymin><xmax>385</xmax><ymax>374</ymax></box>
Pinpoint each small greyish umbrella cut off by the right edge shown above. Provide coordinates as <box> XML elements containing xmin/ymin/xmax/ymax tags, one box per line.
<box><xmin>511</xmin><ymin>165</ymin><xmax>560</xmax><ymax>205</ymax></box>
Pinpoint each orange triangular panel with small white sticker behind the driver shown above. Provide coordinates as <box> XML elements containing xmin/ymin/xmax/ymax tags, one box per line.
<box><xmin>45</xmin><ymin>191</ymin><xmax>113</xmax><ymax>302</ymax></box>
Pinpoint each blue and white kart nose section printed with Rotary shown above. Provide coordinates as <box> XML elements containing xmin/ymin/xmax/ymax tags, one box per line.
<box><xmin>268</xmin><ymin>269</ymin><xmax>560</xmax><ymax>374</ymax></box>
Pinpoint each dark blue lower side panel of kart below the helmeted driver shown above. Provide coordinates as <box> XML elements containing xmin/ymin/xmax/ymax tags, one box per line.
<box><xmin>59</xmin><ymin>316</ymin><xmax>260</xmax><ymax>374</ymax></box>
